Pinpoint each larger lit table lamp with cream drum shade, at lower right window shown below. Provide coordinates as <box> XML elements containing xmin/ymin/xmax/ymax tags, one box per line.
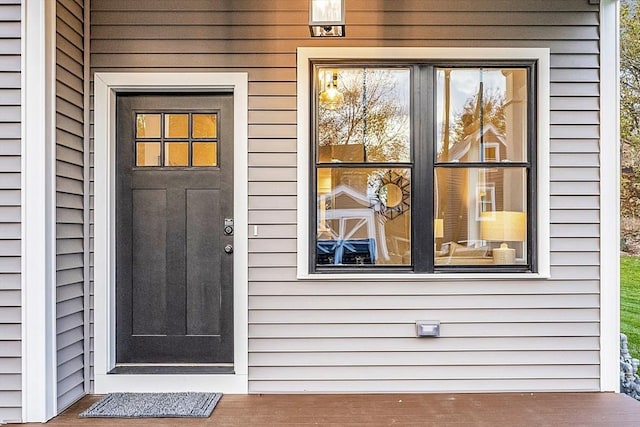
<box><xmin>480</xmin><ymin>211</ymin><xmax>527</xmax><ymax>264</ymax></box>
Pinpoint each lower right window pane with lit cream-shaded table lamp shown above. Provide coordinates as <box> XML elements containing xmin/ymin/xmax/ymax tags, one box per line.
<box><xmin>433</xmin><ymin>167</ymin><xmax>527</xmax><ymax>265</ymax></box>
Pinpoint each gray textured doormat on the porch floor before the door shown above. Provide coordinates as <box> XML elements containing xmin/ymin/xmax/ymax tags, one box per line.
<box><xmin>80</xmin><ymin>392</ymin><xmax>222</xmax><ymax>418</ymax></box>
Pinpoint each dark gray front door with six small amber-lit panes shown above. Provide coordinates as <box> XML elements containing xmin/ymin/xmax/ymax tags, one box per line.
<box><xmin>116</xmin><ymin>94</ymin><xmax>233</xmax><ymax>366</ymax></box>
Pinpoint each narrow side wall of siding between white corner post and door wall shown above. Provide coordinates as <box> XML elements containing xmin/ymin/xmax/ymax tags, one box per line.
<box><xmin>56</xmin><ymin>0</ymin><xmax>85</xmax><ymax>411</ymax></box>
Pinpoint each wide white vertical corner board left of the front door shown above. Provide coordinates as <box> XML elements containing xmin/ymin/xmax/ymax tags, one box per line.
<box><xmin>20</xmin><ymin>1</ymin><xmax>57</xmax><ymax>422</ymax></box>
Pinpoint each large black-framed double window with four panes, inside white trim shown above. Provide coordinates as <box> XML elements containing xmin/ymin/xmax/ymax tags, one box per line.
<box><xmin>309</xmin><ymin>61</ymin><xmax>536</xmax><ymax>273</ymax></box>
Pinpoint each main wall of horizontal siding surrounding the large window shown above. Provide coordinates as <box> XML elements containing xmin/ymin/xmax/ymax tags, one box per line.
<box><xmin>91</xmin><ymin>0</ymin><xmax>600</xmax><ymax>392</ymax></box>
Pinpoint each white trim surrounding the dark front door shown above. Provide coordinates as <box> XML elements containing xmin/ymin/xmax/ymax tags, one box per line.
<box><xmin>94</xmin><ymin>73</ymin><xmax>248</xmax><ymax>394</ymax></box>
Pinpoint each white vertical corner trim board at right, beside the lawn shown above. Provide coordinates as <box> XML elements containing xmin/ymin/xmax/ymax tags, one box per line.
<box><xmin>600</xmin><ymin>0</ymin><xmax>620</xmax><ymax>392</ymax></box>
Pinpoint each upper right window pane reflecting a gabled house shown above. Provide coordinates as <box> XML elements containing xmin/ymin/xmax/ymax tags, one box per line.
<box><xmin>436</xmin><ymin>68</ymin><xmax>527</xmax><ymax>162</ymax></box>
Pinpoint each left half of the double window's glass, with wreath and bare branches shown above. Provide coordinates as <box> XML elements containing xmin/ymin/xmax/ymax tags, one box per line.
<box><xmin>315</xmin><ymin>67</ymin><xmax>411</xmax><ymax>266</ymax></box>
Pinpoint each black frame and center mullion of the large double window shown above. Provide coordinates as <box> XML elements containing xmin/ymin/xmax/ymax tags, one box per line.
<box><xmin>308</xmin><ymin>59</ymin><xmax>538</xmax><ymax>275</ymax></box>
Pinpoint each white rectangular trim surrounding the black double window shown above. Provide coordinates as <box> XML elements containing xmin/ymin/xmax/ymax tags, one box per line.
<box><xmin>297</xmin><ymin>47</ymin><xmax>551</xmax><ymax>281</ymax></box>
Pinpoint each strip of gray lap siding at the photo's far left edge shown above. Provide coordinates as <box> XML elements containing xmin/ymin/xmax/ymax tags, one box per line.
<box><xmin>0</xmin><ymin>0</ymin><xmax>22</xmax><ymax>423</ymax></box>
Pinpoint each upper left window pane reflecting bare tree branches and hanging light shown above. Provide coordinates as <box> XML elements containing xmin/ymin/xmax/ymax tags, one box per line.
<box><xmin>316</xmin><ymin>67</ymin><xmax>411</xmax><ymax>163</ymax></box>
